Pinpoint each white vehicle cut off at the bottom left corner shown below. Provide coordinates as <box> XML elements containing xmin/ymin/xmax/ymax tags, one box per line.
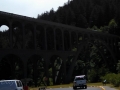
<box><xmin>0</xmin><ymin>80</ymin><xmax>24</xmax><ymax>90</ymax></box>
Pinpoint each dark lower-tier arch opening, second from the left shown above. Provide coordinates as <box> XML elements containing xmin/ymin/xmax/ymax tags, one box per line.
<box><xmin>27</xmin><ymin>55</ymin><xmax>45</xmax><ymax>87</ymax></box>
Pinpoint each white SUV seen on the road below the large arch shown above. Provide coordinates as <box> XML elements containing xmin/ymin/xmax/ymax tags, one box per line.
<box><xmin>73</xmin><ymin>75</ymin><xmax>87</xmax><ymax>89</ymax></box>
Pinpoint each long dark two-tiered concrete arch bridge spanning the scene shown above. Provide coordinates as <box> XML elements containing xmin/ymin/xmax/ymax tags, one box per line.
<box><xmin>0</xmin><ymin>11</ymin><xmax>120</xmax><ymax>85</ymax></box>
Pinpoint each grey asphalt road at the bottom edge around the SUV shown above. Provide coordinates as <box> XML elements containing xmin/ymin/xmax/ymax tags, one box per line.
<box><xmin>47</xmin><ymin>87</ymin><xmax>102</xmax><ymax>90</ymax></box>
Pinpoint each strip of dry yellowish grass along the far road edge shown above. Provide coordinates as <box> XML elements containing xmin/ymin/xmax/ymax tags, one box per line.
<box><xmin>29</xmin><ymin>82</ymin><xmax>106</xmax><ymax>90</ymax></box>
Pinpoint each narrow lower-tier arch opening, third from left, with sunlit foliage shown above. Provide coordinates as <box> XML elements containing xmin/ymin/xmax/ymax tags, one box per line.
<box><xmin>49</xmin><ymin>55</ymin><xmax>63</xmax><ymax>85</ymax></box>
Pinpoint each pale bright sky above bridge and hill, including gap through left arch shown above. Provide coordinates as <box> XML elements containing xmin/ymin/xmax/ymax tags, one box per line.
<box><xmin>0</xmin><ymin>0</ymin><xmax>71</xmax><ymax>31</ymax></box>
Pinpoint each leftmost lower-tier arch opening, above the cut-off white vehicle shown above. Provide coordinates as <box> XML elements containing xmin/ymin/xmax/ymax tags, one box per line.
<box><xmin>0</xmin><ymin>54</ymin><xmax>24</xmax><ymax>79</ymax></box>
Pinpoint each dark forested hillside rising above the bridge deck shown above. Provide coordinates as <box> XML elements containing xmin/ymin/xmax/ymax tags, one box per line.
<box><xmin>37</xmin><ymin>0</ymin><xmax>120</xmax><ymax>35</ymax></box>
